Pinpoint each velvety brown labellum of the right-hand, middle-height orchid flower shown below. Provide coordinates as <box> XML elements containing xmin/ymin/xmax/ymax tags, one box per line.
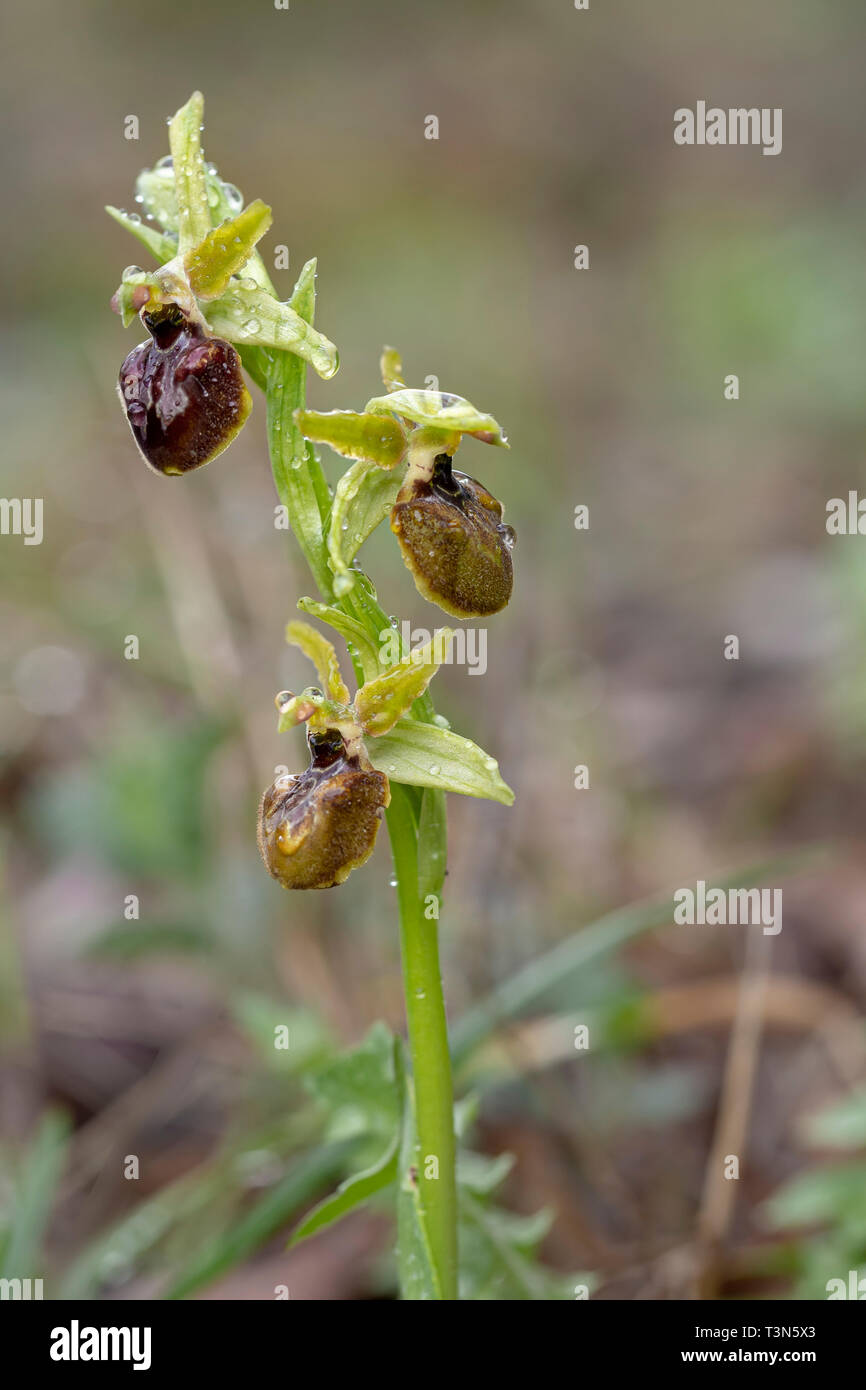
<box><xmin>391</xmin><ymin>453</ymin><xmax>514</xmax><ymax>617</ymax></box>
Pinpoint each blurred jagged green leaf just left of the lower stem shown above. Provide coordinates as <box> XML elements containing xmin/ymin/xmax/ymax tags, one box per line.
<box><xmin>304</xmin><ymin>1023</ymin><xmax>403</xmax><ymax>1140</ymax></box>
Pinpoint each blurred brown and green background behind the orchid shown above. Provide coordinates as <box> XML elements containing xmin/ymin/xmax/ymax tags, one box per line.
<box><xmin>0</xmin><ymin>0</ymin><xmax>866</xmax><ymax>1298</ymax></box>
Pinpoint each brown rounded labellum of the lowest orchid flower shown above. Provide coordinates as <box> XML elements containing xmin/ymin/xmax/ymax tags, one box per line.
<box><xmin>259</xmin><ymin>730</ymin><xmax>391</xmax><ymax>888</ymax></box>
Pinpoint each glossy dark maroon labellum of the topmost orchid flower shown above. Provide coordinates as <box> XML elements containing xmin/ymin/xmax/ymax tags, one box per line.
<box><xmin>118</xmin><ymin>306</ymin><xmax>253</xmax><ymax>475</ymax></box>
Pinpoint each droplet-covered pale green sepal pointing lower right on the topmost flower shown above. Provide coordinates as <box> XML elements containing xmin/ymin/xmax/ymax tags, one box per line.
<box><xmin>206</xmin><ymin>284</ymin><xmax>339</xmax><ymax>379</ymax></box>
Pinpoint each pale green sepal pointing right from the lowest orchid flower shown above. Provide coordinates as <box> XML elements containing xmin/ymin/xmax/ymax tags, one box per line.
<box><xmin>367</xmin><ymin>719</ymin><xmax>514</xmax><ymax>806</ymax></box>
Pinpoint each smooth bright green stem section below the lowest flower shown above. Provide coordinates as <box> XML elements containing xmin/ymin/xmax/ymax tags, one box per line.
<box><xmin>386</xmin><ymin>785</ymin><xmax>457</xmax><ymax>1300</ymax></box>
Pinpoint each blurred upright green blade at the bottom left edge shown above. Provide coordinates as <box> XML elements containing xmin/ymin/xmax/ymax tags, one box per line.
<box><xmin>0</xmin><ymin>1111</ymin><xmax>70</xmax><ymax>1279</ymax></box>
